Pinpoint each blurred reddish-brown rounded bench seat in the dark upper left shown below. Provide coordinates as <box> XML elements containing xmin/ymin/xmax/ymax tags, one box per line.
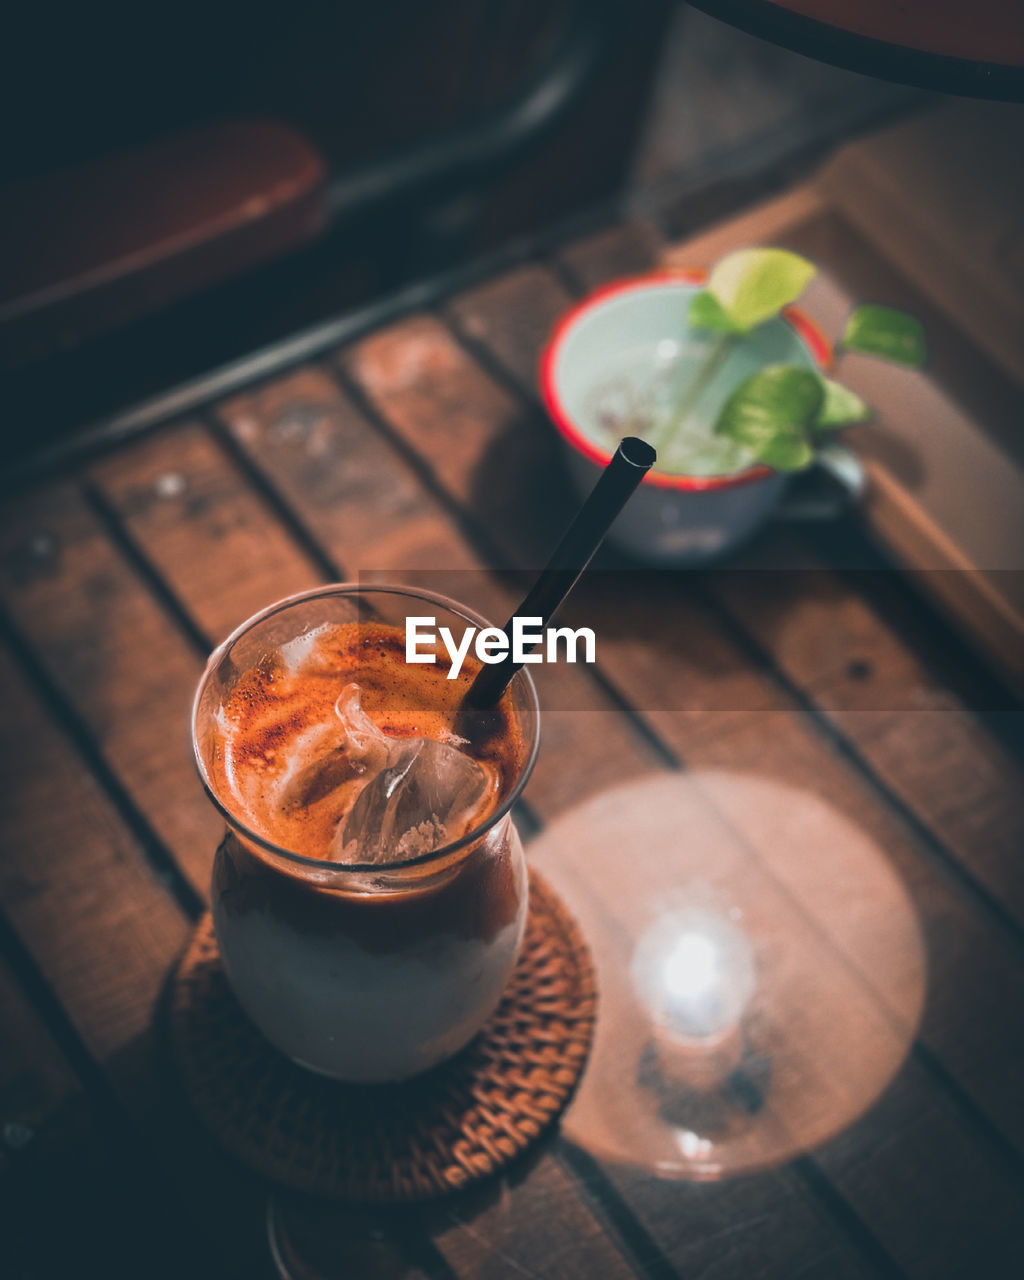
<box><xmin>0</xmin><ymin>120</ymin><xmax>325</xmax><ymax>362</ymax></box>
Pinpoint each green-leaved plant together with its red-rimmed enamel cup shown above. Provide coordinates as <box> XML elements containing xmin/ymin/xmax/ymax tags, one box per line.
<box><xmin>541</xmin><ymin>248</ymin><xmax>925</xmax><ymax>564</ymax></box>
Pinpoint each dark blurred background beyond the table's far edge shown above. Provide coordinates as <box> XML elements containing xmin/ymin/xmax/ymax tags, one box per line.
<box><xmin>0</xmin><ymin>0</ymin><xmax>957</xmax><ymax>456</ymax></box>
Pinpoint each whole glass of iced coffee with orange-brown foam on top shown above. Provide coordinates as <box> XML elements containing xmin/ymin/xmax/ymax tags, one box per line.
<box><xmin>192</xmin><ymin>585</ymin><xmax>539</xmax><ymax>1083</ymax></box>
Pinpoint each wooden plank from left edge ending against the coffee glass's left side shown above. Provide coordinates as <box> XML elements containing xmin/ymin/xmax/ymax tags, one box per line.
<box><xmin>0</xmin><ymin>484</ymin><xmax>221</xmax><ymax>896</ymax></box>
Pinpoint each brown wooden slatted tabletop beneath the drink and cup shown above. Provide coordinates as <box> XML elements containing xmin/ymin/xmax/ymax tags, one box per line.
<box><xmin>0</xmin><ymin>225</ymin><xmax>1024</xmax><ymax>1280</ymax></box>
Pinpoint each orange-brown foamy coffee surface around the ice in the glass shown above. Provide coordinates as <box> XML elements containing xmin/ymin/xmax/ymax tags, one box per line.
<box><xmin>211</xmin><ymin>622</ymin><xmax>526</xmax><ymax>858</ymax></box>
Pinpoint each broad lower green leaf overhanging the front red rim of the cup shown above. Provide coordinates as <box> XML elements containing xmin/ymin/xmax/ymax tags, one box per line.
<box><xmin>714</xmin><ymin>365</ymin><xmax>824</xmax><ymax>471</ymax></box>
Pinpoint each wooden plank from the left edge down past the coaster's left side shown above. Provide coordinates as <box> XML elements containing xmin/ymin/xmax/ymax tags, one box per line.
<box><xmin>0</xmin><ymin>649</ymin><xmax>276</xmax><ymax>1275</ymax></box>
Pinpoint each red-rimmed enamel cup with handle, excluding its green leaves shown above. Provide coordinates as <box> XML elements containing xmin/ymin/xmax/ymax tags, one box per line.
<box><xmin>540</xmin><ymin>271</ymin><xmax>864</xmax><ymax>566</ymax></box>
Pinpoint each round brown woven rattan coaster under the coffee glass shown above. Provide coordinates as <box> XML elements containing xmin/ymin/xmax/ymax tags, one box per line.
<box><xmin>170</xmin><ymin>872</ymin><xmax>595</xmax><ymax>1202</ymax></box>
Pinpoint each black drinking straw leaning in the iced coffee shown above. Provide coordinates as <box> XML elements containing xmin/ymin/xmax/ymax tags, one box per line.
<box><xmin>466</xmin><ymin>435</ymin><xmax>658</xmax><ymax>710</ymax></box>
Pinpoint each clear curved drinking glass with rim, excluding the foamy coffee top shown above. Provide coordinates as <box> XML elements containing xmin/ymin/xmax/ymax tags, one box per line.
<box><xmin>192</xmin><ymin>584</ymin><xmax>539</xmax><ymax>1083</ymax></box>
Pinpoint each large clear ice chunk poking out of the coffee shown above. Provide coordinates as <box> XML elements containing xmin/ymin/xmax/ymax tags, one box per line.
<box><xmin>330</xmin><ymin>685</ymin><xmax>489</xmax><ymax>863</ymax></box>
